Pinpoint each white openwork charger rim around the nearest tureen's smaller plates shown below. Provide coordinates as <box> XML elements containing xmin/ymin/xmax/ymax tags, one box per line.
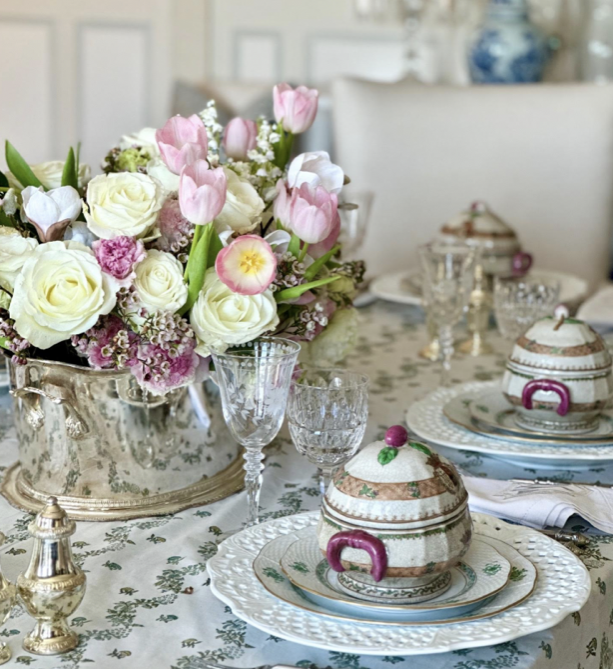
<box><xmin>207</xmin><ymin>511</ymin><xmax>590</xmax><ymax>656</ymax></box>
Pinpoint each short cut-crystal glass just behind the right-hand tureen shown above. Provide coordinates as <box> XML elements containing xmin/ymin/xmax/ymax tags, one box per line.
<box><xmin>494</xmin><ymin>277</ymin><xmax>560</xmax><ymax>341</ymax></box>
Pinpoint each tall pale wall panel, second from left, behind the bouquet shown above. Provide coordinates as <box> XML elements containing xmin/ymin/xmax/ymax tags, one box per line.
<box><xmin>78</xmin><ymin>24</ymin><xmax>150</xmax><ymax>167</ymax></box>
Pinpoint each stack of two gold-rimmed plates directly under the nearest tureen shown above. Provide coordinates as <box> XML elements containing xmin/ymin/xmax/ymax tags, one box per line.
<box><xmin>270</xmin><ymin>528</ymin><xmax>512</xmax><ymax>625</ymax></box>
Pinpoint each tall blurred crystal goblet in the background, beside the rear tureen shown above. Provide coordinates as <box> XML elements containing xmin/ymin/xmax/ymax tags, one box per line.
<box><xmin>419</xmin><ymin>243</ymin><xmax>479</xmax><ymax>387</ymax></box>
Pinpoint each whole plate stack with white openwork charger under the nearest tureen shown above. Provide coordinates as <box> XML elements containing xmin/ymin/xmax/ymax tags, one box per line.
<box><xmin>208</xmin><ymin>512</ymin><xmax>590</xmax><ymax>655</ymax></box>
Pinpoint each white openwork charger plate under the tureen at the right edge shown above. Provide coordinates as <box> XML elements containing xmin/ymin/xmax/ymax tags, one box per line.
<box><xmin>407</xmin><ymin>381</ymin><xmax>613</xmax><ymax>469</ymax></box>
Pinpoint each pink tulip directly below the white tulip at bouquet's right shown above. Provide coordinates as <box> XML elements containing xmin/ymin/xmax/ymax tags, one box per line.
<box><xmin>290</xmin><ymin>184</ymin><xmax>338</xmax><ymax>244</ymax></box>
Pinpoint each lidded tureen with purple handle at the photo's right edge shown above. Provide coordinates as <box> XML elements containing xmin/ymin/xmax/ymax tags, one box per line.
<box><xmin>502</xmin><ymin>313</ymin><xmax>613</xmax><ymax>434</ymax></box>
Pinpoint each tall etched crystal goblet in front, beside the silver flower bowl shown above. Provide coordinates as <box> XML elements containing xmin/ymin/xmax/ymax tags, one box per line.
<box><xmin>212</xmin><ymin>337</ymin><xmax>300</xmax><ymax>527</ymax></box>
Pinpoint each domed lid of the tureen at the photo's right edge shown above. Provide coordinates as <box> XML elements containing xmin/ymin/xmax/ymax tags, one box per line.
<box><xmin>509</xmin><ymin>313</ymin><xmax>611</xmax><ymax>372</ymax></box>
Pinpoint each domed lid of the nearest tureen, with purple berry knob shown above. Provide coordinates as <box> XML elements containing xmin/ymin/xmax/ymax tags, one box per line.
<box><xmin>324</xmin><ymin>425</ymin><xmax>467</xmax><ymax>529</ymax></box>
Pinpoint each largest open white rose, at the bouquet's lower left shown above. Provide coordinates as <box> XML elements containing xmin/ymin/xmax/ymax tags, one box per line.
<box><xmin>10</xmin><ymin>242</ymin><xmax>116</xmax><ymax>349</ymax></box>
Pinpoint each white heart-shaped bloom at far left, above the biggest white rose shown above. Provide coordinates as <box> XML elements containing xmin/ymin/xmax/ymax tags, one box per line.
<box><xmin>21</xmin><ymin>186</ymin><xmax>83</xmax><ymax>242</ymax></box>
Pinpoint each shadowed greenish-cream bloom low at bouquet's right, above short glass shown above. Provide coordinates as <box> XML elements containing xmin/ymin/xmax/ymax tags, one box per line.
<box><xmin>301</xmin><ymin>309</ymin><xmax>359</xmax><ymax>367</ymax></box>
